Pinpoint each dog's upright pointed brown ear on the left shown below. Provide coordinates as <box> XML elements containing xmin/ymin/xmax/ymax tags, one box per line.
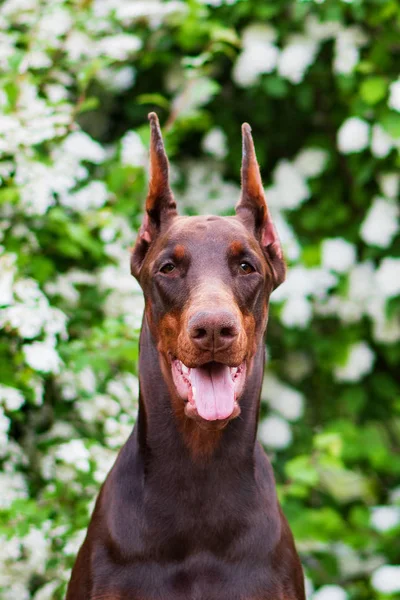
<box><xmin>131</xmin><ymin>113</ymin><xmax>177</xmax><ymax>277</ymax></box>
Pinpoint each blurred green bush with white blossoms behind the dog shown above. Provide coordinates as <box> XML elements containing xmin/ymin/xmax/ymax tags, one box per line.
<box><xmin>0</xmin><ymin>0</ymin><xmax>400</xmax><ymax>600</ymax></box>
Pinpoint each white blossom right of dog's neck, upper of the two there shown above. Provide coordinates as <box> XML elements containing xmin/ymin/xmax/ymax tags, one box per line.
<box><xmin>261</xmin><ymin>374</ymin><xmax>304</xmax><ymax>421</ymax></box>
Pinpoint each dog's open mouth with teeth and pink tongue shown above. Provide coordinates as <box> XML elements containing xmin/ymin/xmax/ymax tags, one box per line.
<box><xmin>171</xmin><ymin>359</ymin><xmax>246</xmax><ymax>424</ymax></box>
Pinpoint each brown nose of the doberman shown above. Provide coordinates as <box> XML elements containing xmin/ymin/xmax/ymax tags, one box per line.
<box><xmin>188</xmin><ymin>310</ymin><xmax>239</xmax><ymax>352</ymax></box>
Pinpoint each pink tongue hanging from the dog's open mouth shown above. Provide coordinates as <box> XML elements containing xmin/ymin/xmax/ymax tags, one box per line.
<box><xmin>190</xmin><ymin>363</ymin><xmax>235</xmax><ymax>421</ymax></box>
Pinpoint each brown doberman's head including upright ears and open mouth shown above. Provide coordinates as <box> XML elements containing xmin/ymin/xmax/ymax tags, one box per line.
<box><xmin>131</xmin><ymin>113</ymin><xmax>285</xmax><ymax>428</ymax></box>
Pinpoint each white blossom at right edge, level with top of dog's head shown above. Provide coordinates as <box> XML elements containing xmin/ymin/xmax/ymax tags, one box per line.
<box><xmin>360</xmin><ymin>197</ymin><xmax>399</xmax><ymax>248</ymax></box>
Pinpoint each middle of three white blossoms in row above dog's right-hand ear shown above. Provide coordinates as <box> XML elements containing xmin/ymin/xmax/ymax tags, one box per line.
<box><xmin>278</xmin><ymin>35</ymin><xmax>318</xmax><ymax>84</ymax></box>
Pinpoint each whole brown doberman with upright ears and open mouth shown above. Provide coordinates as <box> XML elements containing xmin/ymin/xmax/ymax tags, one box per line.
<box><xmin>67</xmin><ymin>113</ymin><xmax>305</xmax><ymax>600</ymax></box>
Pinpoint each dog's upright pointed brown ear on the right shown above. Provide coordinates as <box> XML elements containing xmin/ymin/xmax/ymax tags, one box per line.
<box><xmin>236</xmin><ymin>123</ymin><xmax>286</xmax><ymax>288</ymax></box>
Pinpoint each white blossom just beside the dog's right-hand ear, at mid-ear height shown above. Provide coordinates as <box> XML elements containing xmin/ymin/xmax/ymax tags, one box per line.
<box><xmin>266</xmin><ymin>160</ymin><xmax>310</xmax><ymax>210</ymax></box>
